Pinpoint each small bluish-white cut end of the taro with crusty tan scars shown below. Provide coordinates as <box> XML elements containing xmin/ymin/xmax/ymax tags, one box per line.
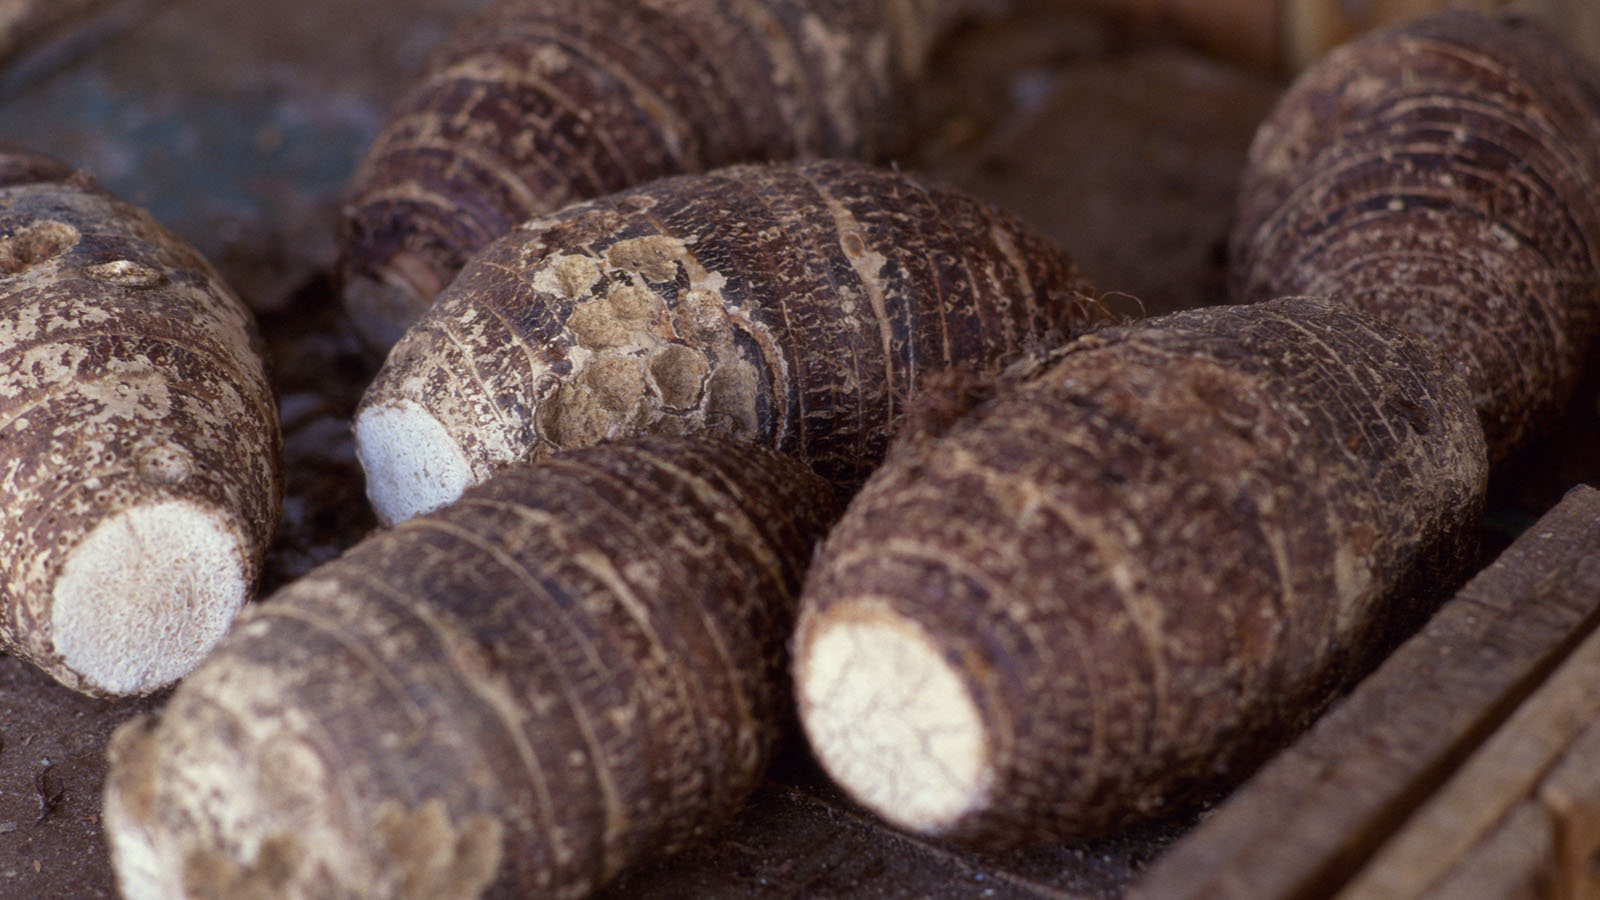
<box><xmin>355</xmin><ymin>400</ymin><xmax>472</xmax><ymax>525</ymax></box>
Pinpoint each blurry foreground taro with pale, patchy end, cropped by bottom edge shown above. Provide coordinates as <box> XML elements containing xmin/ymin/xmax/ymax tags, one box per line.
<box><xmin>106</xmin><ymin>437</ymin><xmax>838</xmax><ymax>900</ymax></box>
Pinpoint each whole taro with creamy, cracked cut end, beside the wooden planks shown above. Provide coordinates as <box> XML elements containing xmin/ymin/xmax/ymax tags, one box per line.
<box><xmin>795</xmin><ymin>299</ymin><xmax>1486</xmax><ymax>846</ymax></box>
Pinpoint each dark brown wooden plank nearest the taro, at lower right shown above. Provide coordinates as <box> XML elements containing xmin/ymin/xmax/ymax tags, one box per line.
<box><xmin>1128</xmin><ymin>487</ymin><xmax>1600</xmax><ymax>900</ymax></box>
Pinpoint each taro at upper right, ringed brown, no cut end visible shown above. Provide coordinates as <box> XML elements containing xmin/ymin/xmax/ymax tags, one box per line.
<box><xmin>1230</xmin><ymin>13</ymin><xmax>1600</xmax><ymax>460</ymax></box>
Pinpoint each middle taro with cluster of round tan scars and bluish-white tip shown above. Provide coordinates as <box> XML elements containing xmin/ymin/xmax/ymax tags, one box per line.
<box><xmin>355</xmin><ymin>162</ymin><xmax>1101</xmax><ymax>520</ymax></box>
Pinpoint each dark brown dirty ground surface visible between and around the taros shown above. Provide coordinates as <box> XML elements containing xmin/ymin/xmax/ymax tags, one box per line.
<box><xmin>0</xmin><ymin>0</ymin><xmax>1600</xmax><ymax>900</ymax></box>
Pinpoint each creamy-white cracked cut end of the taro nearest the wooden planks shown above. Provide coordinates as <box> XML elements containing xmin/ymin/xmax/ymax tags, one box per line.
<box><xmin>795</xmin><ymin>607</ymin><xmax>994</xmax><ymax>833</ymax></box>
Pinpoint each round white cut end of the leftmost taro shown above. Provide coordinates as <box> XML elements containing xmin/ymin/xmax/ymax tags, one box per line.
<box><xmin>50</xmin><ymin>500</ymin><xmax>250</xmax><ymax>695</ymax></box>
